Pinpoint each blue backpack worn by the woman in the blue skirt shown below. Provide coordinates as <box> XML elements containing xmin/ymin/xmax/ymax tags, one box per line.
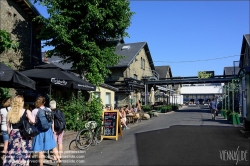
<box><xmin>37</xmin><ymin>107</ymin><xmax>53</xmax><ymax>131</ymax></box>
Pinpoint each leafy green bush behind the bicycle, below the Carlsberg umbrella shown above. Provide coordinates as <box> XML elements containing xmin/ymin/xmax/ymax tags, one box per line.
<box><xmin>51</xmin><ymin>93</ymin><xmax>102</xmax><ymax>131</ymax></box>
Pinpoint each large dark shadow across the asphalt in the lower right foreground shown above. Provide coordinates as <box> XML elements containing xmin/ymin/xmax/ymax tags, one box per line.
<box><xmin>135</xmin><ymin>125</ymin><xmax>250</xmax><ymax>166</ymax></box>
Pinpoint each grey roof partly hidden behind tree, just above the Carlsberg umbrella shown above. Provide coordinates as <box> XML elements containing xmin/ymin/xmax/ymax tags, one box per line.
<box><xmin>42</xmin><ymin>52</ymin><xmax>73</xmax><ymax>70</ymax></box>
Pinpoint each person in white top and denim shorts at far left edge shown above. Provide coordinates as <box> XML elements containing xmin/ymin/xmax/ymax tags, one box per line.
<box><xmin>0</xmin><ymin>97</ymin><xmax>11</xmax><ymax>155</ymax></box>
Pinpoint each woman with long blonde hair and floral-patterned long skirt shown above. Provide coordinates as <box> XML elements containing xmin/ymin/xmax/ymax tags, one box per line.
<box><xmin>3</xmin><ymin>96</ymin><xmax>35</xmax><ymax>166</ymax></box>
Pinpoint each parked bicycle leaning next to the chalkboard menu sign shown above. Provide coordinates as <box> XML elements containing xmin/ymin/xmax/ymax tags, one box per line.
<box><xmin>75</xmin><ymin>121</ymin><xmax>104</xmax><ymax>150</ymax></box>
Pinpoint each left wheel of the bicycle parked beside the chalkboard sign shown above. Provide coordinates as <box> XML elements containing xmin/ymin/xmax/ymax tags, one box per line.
<box><xmin>76</xmin><ymin>129</ymin><xmax>92</xmax><ymax>150</ymax></box>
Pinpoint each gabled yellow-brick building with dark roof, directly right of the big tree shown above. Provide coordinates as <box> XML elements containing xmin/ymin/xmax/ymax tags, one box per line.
<box><xmin>105</xmin><ymin>42</ymin><xmax>158</xmax><ymax>107</ymax></box>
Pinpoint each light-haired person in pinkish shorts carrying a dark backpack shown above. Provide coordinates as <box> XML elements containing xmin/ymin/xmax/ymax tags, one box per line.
<box><xmin>50</xmin><ymin>100</ymin><xmax>66</xmax><ymax>160</ymax></box>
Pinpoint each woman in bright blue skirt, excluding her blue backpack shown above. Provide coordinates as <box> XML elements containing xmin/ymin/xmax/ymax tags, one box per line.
<box><xmin>32</xmin><ymin>96</ymin><xmax>61</xmax><ymax>166</ymax></box>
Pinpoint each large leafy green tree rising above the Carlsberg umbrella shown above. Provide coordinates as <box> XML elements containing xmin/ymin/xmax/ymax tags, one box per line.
<box><xmin>35</xmin><ymin>0</ymin><xmax>134</xmax><ymax>85</ymax></box>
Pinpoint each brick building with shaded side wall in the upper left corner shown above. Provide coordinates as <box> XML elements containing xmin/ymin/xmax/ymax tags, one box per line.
<box><xmin>0</xmin><ymin>0</ymin><xmax>42</xmax><ymax>70</ymax></box>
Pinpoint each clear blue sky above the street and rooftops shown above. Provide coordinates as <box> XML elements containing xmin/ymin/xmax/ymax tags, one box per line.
<box><xmin>31</xmin><ymin>0</ymin><xmax>250</xmax><ymax>77</ymax></box>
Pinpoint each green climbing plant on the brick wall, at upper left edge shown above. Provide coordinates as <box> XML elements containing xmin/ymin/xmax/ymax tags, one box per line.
<box><xmin>0</xmin><ymin>30</ymin><xmax>19</xmax><ymax>54</ymax></box>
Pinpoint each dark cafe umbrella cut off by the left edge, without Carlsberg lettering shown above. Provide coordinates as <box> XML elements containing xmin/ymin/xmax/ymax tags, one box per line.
<box><xmin>0</xmin><ymin>62</ymin><xmax>36</xmax><ymax>90</ymax></box>
